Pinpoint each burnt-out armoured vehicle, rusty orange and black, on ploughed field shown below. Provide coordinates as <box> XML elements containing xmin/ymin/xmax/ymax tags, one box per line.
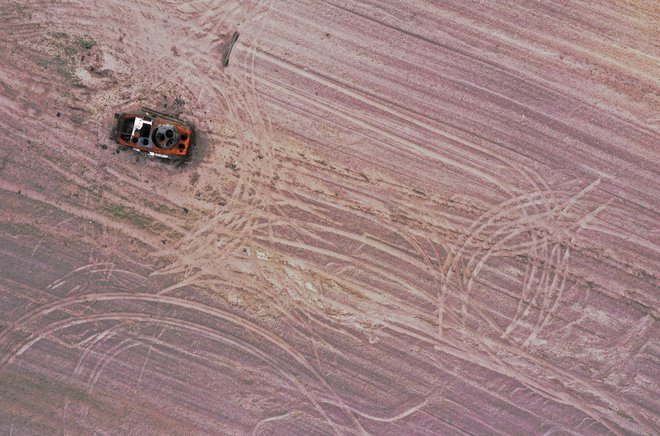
<box><xmin>110</xmin><ymin>107</ymin><xmax>193</xmax><ymax>161</ymax></box>
